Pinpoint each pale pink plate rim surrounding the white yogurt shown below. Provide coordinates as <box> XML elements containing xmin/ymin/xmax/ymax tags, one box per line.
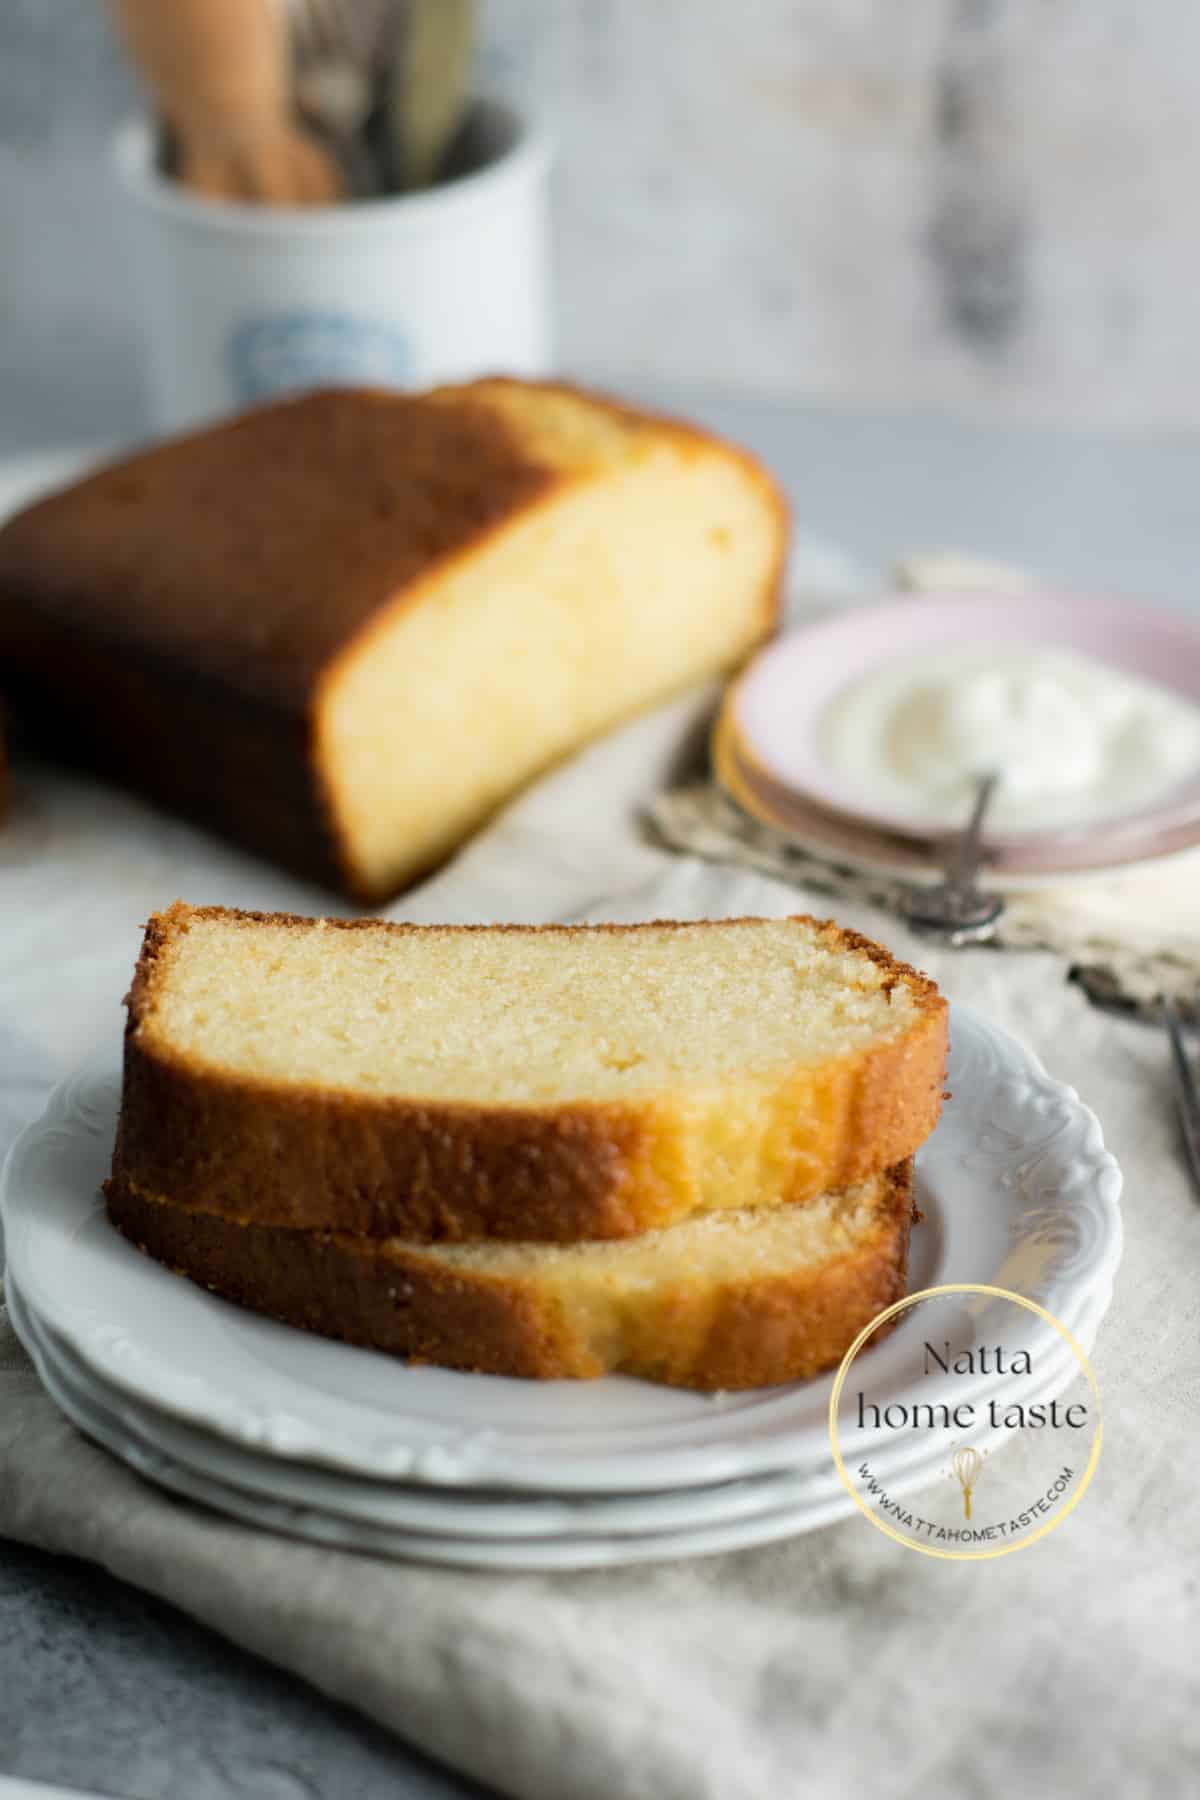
<box><xmin>725</xmin><ymin>590</ymin><xmax>1200</xmax><ymax>849</ymax></box>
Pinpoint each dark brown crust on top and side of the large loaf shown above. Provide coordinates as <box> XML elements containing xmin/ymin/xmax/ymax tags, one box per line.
<box><xmin>0</xmin><ymin>378</ymin><xmax>788</xmax><ymax>902</ymax></box>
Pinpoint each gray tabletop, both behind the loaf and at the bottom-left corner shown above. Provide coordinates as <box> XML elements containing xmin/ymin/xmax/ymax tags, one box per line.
<box><xmin>0</xmin><ymin>372</ymin><xmax>1200</xmax><ymax>1800</ymax></box>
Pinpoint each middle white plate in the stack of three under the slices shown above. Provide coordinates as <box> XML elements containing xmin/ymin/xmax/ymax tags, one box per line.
<box><xmin>7</xmin><ymin>1276</ymin><xmax>1097</xmax><ymax>1539</ymax></box>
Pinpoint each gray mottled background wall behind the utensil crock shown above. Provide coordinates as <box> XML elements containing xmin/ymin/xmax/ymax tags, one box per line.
<box><xmin>0</xmin><ymin>0</ymin><xmax>1200</xmax><ymax>436</ymax></box>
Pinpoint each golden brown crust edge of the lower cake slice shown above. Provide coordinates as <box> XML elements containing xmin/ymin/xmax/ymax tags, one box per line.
<box><xmin>106</xmin><ymin>1163</ymin><xmax>914</xmax><ymax>1390</ymax></box>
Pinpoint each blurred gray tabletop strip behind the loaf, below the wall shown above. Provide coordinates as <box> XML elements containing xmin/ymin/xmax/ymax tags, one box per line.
<box><xmin>0</xmin><ymin>345</ymin><xmax>1200</xmax><ymax>610</ymax></box>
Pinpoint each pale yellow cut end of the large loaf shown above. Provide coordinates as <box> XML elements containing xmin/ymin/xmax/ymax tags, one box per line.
<box><xmin>315</xmin><ymin>380</ymin><xmax>786</xmax><ymax>898</ymax></box>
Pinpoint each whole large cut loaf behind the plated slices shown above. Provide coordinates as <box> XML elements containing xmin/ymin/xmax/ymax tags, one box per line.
<box><xmin>0</xmin><ymin>380</ymin><xmax>786</xmax><ymax>902</ymax></box>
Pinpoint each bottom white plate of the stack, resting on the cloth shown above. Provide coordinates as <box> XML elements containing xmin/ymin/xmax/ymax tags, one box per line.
<box><xmin>9</xmin><ymin>1283</ymin><xmax>1103</xmax><ymax>1570</ymax></box>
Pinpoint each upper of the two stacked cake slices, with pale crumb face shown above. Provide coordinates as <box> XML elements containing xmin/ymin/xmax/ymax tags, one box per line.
<box><xmin>113</xmin><ymin>904</ymin><xmax>946</xmax><ymax>1244</ymax></box>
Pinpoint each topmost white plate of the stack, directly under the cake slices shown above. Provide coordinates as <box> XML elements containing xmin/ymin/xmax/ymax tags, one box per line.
<box><xmin>0</xmin><ymin>1008</ymin><xmax>1121</xmax><ymax>1494</ymax></box>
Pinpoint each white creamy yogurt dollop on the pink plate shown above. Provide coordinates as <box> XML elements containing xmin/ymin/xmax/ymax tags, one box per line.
<box><xmin>819</xmin><ymin>643</ymin><xmax>1200</xmax><ymax>832</ymax></box>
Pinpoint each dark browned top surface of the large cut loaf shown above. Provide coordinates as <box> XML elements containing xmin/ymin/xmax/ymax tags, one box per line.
<box><xmin>0</xmin><ymin>380</ymin><xmax>783</xmax><ymax>711</ymax></box>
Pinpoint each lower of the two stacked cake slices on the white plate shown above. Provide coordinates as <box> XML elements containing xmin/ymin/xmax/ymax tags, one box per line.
<box><xmin>108</xmin><ymin>1163</ymin><xmax>914</xmax><ymax>1390</ymax></box>
